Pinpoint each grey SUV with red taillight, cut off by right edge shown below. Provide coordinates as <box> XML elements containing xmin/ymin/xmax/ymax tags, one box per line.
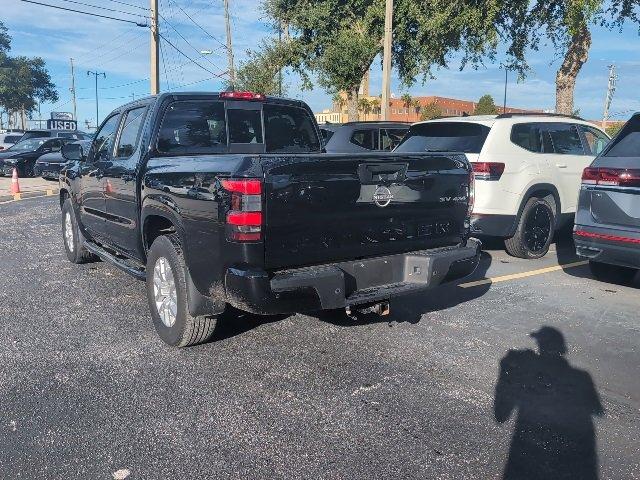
<box><xmin>573</xmin><ymin>113</ymin><xmax>640</xmax><ymax>283</ymax></box>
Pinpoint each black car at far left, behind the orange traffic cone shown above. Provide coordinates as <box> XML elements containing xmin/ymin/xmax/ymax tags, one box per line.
<box><xmin>0</xmin><ymin>138</ymin><xmax>72</xmax><ymax>177</ymax></box>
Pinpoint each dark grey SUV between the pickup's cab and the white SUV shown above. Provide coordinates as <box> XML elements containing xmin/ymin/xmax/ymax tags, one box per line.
<box><xmin>320</xmin><ymin>122</ymin><xmax>409</xmax><ymax>153</ymax></box>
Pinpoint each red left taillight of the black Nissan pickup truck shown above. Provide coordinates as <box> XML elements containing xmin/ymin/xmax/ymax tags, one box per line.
<box><xmin>220</xmin><ymin>178</ymin><xmax>262</xmax><ymax>242</ymax></box>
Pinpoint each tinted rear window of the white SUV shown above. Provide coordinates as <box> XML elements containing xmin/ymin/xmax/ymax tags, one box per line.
<box><xmin>395</xmin><ymin>122</ymin><xmax>490</xmax><ymax>153</ymax></box>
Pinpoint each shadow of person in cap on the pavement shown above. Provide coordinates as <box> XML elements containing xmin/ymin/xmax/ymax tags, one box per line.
<box><xmin>494</xmin><ymin>326</ymin><xmax>604</xmax><ymax>480</ymax></box>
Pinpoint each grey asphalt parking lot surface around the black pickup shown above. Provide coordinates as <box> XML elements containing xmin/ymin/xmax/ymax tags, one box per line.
<box><xmin>0</xmin><ymin>197</ymin><xmax>640</xmax><ymax>479</ymax></box>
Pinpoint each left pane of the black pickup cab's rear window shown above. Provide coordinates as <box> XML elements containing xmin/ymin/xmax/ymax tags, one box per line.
<box><xmin>157</xmin><ymin>100</ymin><xmax>227</xmax><ymax>155</ymax></box>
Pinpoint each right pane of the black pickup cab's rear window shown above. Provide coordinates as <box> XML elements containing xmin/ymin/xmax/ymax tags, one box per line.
<box><xmin>263</xmin><ymin>104</ymin><xmax>320</xmax><ymax>153</ymax></box>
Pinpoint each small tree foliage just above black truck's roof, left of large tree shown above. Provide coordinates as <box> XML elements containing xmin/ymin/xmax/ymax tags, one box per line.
<box><xmin>226</xmin><ymin>41</ymin><xmax>287</xmax><ymax>96</ymax></box>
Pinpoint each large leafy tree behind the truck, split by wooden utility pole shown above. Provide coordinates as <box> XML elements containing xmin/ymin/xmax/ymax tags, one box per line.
<box><xmin>264</xmin><ymin>0</ymin><xmax>498</xmax><ymax>120</ymax></box>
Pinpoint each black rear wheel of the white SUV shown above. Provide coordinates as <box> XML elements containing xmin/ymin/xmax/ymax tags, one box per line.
<box><xmin>504</xmin><ymin>197</ymin><xmax>556</xmax><ymax>259</ymax></box>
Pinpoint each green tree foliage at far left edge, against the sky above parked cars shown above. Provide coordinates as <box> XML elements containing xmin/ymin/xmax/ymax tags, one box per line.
<box><xmin>0</xmin><ymin>23</ymin><xmax>58</xmax><ymax>124</ymax></box>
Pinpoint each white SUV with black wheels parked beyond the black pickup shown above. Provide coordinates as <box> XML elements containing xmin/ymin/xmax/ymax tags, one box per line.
<box><xmin>396</xmin><ymin>114</ymin><xmax>609</xmax><ymax>258</ymax></box>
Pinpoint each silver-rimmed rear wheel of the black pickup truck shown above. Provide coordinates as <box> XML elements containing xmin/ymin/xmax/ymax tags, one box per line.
<box><xmin>147</xmin><ymin>233</ymin><xmax>216</xmax><ymax>348</ymax></box>
